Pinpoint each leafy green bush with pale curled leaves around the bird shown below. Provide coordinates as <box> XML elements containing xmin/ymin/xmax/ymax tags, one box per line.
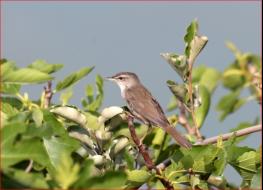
<box><xmin>1</xmin><ymin>20</ymin><xmax>262</xmax><ymax>189</ymax></box>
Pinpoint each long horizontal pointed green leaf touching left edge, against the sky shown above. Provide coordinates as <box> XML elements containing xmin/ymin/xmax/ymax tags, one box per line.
<box><xmin>2</xmin><ymin>68</ymin><xmax>53</xmax><ymax>84</ymax></box>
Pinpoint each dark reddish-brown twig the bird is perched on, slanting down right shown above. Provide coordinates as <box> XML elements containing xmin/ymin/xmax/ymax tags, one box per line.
<box><xmin>128</xmin><ymin>114</ymin><xmax>174</xmax><ymax>190</ymax></box>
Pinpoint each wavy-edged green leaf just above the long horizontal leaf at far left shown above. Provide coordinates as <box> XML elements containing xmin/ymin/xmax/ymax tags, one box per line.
<box><xmin>28</xmin><ymin>59</ymin><xmax>63</xmax><ymax>74</ymax></box>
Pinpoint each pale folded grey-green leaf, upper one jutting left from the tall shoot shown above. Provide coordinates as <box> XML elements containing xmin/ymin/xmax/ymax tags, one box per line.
<box><xmin>161</xmin><ymin>53</ymin><xmax>189</xmax><ymax>81</ymax></box>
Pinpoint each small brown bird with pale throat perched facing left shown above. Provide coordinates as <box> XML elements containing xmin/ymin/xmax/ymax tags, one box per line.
<box><xmin>107</xmin><ymin>72</ymin><xmax>192</xmax><ymax>148</ymax></box>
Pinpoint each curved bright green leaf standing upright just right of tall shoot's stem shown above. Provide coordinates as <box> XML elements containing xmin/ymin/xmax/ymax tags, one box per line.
<box><xmin>195</xmin><ymin>85</ymin><xmax>211</xmax><ymax>128</ymax></box>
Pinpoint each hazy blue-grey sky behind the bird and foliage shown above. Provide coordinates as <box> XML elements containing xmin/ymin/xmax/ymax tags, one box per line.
<box><xmin>1</xmin><ymin>1</ymin><xmax>261</xmax><ymax>186</ymax></box>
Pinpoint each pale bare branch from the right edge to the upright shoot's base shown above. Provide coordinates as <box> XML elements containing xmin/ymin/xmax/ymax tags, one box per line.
<box><xmin>194</xmin><ymin>125</ymin><xmax>262</xmax><ymax>145</ymax></box>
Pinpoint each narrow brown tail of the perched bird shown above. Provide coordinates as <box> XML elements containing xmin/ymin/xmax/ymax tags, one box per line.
<box><xmin>163</xmin><ymin>125</ymin><xmax>192</xmax><ymax>149</ymax></box>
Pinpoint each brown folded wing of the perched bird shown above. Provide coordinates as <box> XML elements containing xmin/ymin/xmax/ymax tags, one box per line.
<box><xmin>125</xmin><ymin>87</ymin><xmax>169</xmax><ymax>126</ymax></box>
